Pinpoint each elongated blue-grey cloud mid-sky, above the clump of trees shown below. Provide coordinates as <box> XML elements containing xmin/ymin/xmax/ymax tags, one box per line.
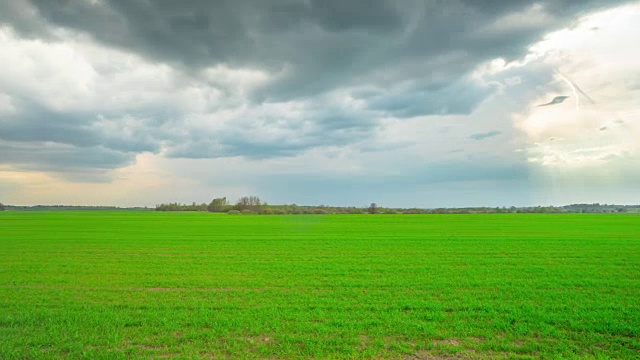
<box><xmin>166</xmin><ymin>104</ymin><xmax>376</xmax><ymax>159</ymax></box>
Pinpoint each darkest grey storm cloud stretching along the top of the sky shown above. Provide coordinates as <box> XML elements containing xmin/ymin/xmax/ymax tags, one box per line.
<box><xmin>4</xmin><ymin>0</ymin><xmax>623</xmax><ymax>100</ymax></box>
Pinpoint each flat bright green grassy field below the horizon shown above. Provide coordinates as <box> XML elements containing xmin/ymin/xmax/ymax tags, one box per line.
<box><xmin>0</xmin><ymin>211</ymin><xmax>640</xmax><ymax>359</ymax></box>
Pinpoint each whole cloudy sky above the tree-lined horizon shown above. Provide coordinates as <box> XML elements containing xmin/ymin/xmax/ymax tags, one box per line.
<box><xmin>0</xmin><ymin>0</ymin><xmax>640</xmax><ymax>208</ymax></box>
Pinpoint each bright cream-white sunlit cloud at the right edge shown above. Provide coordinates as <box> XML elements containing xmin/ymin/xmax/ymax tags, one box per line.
<box><xmin>496</xmin><ymin>5</ymin><xmax>640</xmax><ymax>167</ymax></box>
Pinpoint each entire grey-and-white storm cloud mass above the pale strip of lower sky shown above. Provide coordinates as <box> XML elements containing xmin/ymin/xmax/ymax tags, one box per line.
<box><xmin>0</xmin><ymin>0</ymin><xmax>632</xmax><ymax>205</ymax></box>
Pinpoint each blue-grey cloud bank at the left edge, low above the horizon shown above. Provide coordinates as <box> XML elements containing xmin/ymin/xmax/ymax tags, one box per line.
<box><xmin>0</xmin><ymin>95</ymin><xmax>176</xmax><ymax>176</ymax></box>
